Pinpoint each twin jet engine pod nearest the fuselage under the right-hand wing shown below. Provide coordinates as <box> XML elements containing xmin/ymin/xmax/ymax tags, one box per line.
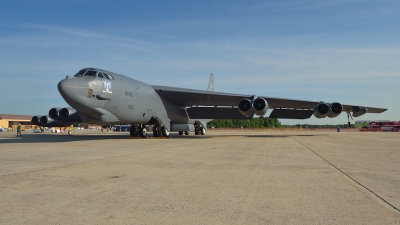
<box><xmin>238</xmin><ymin>98</ymin><xmax>268</xmax><ymax>117</ymax></box>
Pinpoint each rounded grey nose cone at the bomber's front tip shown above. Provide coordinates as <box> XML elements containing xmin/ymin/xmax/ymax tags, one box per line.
<box><xmin>58</xmin><ymin>78</ymin><xmax>89</xmax><ymax>102</ymax></box>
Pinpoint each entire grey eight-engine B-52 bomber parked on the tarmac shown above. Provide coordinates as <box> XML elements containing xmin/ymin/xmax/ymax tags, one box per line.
<box><xmin>32</xmin><ymin>68</ymin><xmax>386</xmax><ymax>138</ymax></box>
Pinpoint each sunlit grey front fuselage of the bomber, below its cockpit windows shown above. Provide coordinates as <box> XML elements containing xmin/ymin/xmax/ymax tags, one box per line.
<box><xmin>58</xmin><ymin>68</ymin><xmax>168</xmax><ymax>124</ymax></box>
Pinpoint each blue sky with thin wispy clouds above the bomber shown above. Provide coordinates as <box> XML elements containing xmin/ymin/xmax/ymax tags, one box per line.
<box><xmin>0</xmin><ymin>0</ymin><xmax>400</xmax><ymax>124</ymax></box>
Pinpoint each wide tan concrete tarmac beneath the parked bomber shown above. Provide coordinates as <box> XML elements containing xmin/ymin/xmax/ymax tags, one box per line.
<box><xmin>0</xmin><ymin>131</ymin><xmax>400</xmax><ymax>224</ymax></box>
